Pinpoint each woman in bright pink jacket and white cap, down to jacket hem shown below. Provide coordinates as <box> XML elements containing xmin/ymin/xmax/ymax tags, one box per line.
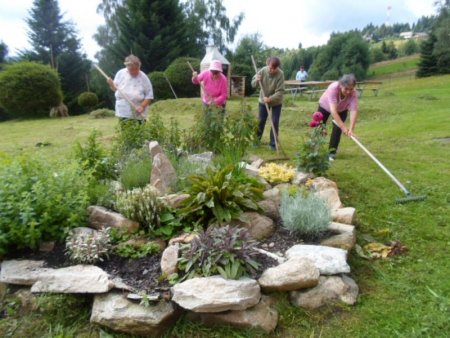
<box><xmin>192</xmin><ymin>60</ymin><xmax>228</xmax><ymax>112</ymax></box>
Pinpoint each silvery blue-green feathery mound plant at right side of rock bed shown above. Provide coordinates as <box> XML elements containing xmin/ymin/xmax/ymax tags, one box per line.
<box><xmin>280</xmin><ymin>191</ymin><xmax>331</xmax><ymax>237</ymax></box>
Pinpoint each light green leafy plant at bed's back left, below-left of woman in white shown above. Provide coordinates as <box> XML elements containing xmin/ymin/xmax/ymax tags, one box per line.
<box><xmin>75</xmin><ymin>129</ymin><xmax>114</xmax><ymax>180</ymax></box>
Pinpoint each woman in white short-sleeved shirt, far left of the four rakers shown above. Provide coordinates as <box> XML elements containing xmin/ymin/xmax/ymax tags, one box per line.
<box><xmin>107</xmin><ymin>55</ymin><xmax>153</xmax><ymax>122</ymax></box>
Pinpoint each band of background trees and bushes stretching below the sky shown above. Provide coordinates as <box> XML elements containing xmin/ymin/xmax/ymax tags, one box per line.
<box><xmin>0</xmin><ymin>0</ymin><xmax>450</xmax><ymax>116</ymax></box>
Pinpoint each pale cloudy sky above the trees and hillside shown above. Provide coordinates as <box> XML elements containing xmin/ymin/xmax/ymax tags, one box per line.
<box><xmin>0</xmin><ymin>0</ymin><xmax>436</xmax><ymax>59</ymax></box>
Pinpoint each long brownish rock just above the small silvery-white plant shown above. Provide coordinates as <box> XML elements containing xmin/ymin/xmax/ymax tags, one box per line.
<box><xmin>88</xmin><ymin>206</ymin><xmax>139</xmax><ymax>232</ymax></box>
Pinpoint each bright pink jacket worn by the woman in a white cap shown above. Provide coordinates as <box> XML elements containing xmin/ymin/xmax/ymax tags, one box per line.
<box><xmin>192</xmin><ymin>70</ymin><xmax>228</xmax><ymax>106</ymax></box>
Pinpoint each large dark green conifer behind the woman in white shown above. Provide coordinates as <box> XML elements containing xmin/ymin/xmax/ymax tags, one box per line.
<box><xmin>95</xmin><ymin>0</ymin><xmax>200</xmax><ymax>73</ymax></box>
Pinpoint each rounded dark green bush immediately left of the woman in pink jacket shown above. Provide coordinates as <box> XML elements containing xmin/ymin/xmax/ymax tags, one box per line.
<box><xmin>165</xmin><ymin>57</ymin><xmax>200</xmax><ymax>97</ymax></box>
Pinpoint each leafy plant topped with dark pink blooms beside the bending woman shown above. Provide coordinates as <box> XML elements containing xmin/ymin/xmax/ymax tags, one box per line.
<box><xmin>295</xmin><ymin>112</ymin><xmax>330</xmax><ymax>176</ymax></box>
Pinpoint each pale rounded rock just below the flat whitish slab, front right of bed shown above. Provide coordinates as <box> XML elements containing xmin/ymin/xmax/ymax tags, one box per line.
<box><xmin>258</xmin><ymin>256</ymin><xmax>320</xmax><ymax>292</ymax></box>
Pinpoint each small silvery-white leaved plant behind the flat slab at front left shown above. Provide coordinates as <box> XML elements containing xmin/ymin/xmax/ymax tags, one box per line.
<box><xmin>66</xmin><ymin>228</ymin><xmax>111</xmax><ymax>264</ymax></box>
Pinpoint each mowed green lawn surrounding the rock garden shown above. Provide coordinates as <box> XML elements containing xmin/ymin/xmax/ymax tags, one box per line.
<box><xmin>0</xmin><ymin>64</ymin><xmax>450</xmax><ymax>338</ymax></box>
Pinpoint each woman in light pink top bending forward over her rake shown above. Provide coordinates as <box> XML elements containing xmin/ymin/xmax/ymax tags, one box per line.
<box><xmin>318</xmin><ymin>74</ymin><xmax>358</xmax><ymax>161</ymax></box>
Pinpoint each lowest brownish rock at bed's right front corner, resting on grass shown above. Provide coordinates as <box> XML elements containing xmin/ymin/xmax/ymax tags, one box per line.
<box><xmin>290</xmin><ymin>275</ymin><xmax>359</xmax><ymax>309</ymax></box>
